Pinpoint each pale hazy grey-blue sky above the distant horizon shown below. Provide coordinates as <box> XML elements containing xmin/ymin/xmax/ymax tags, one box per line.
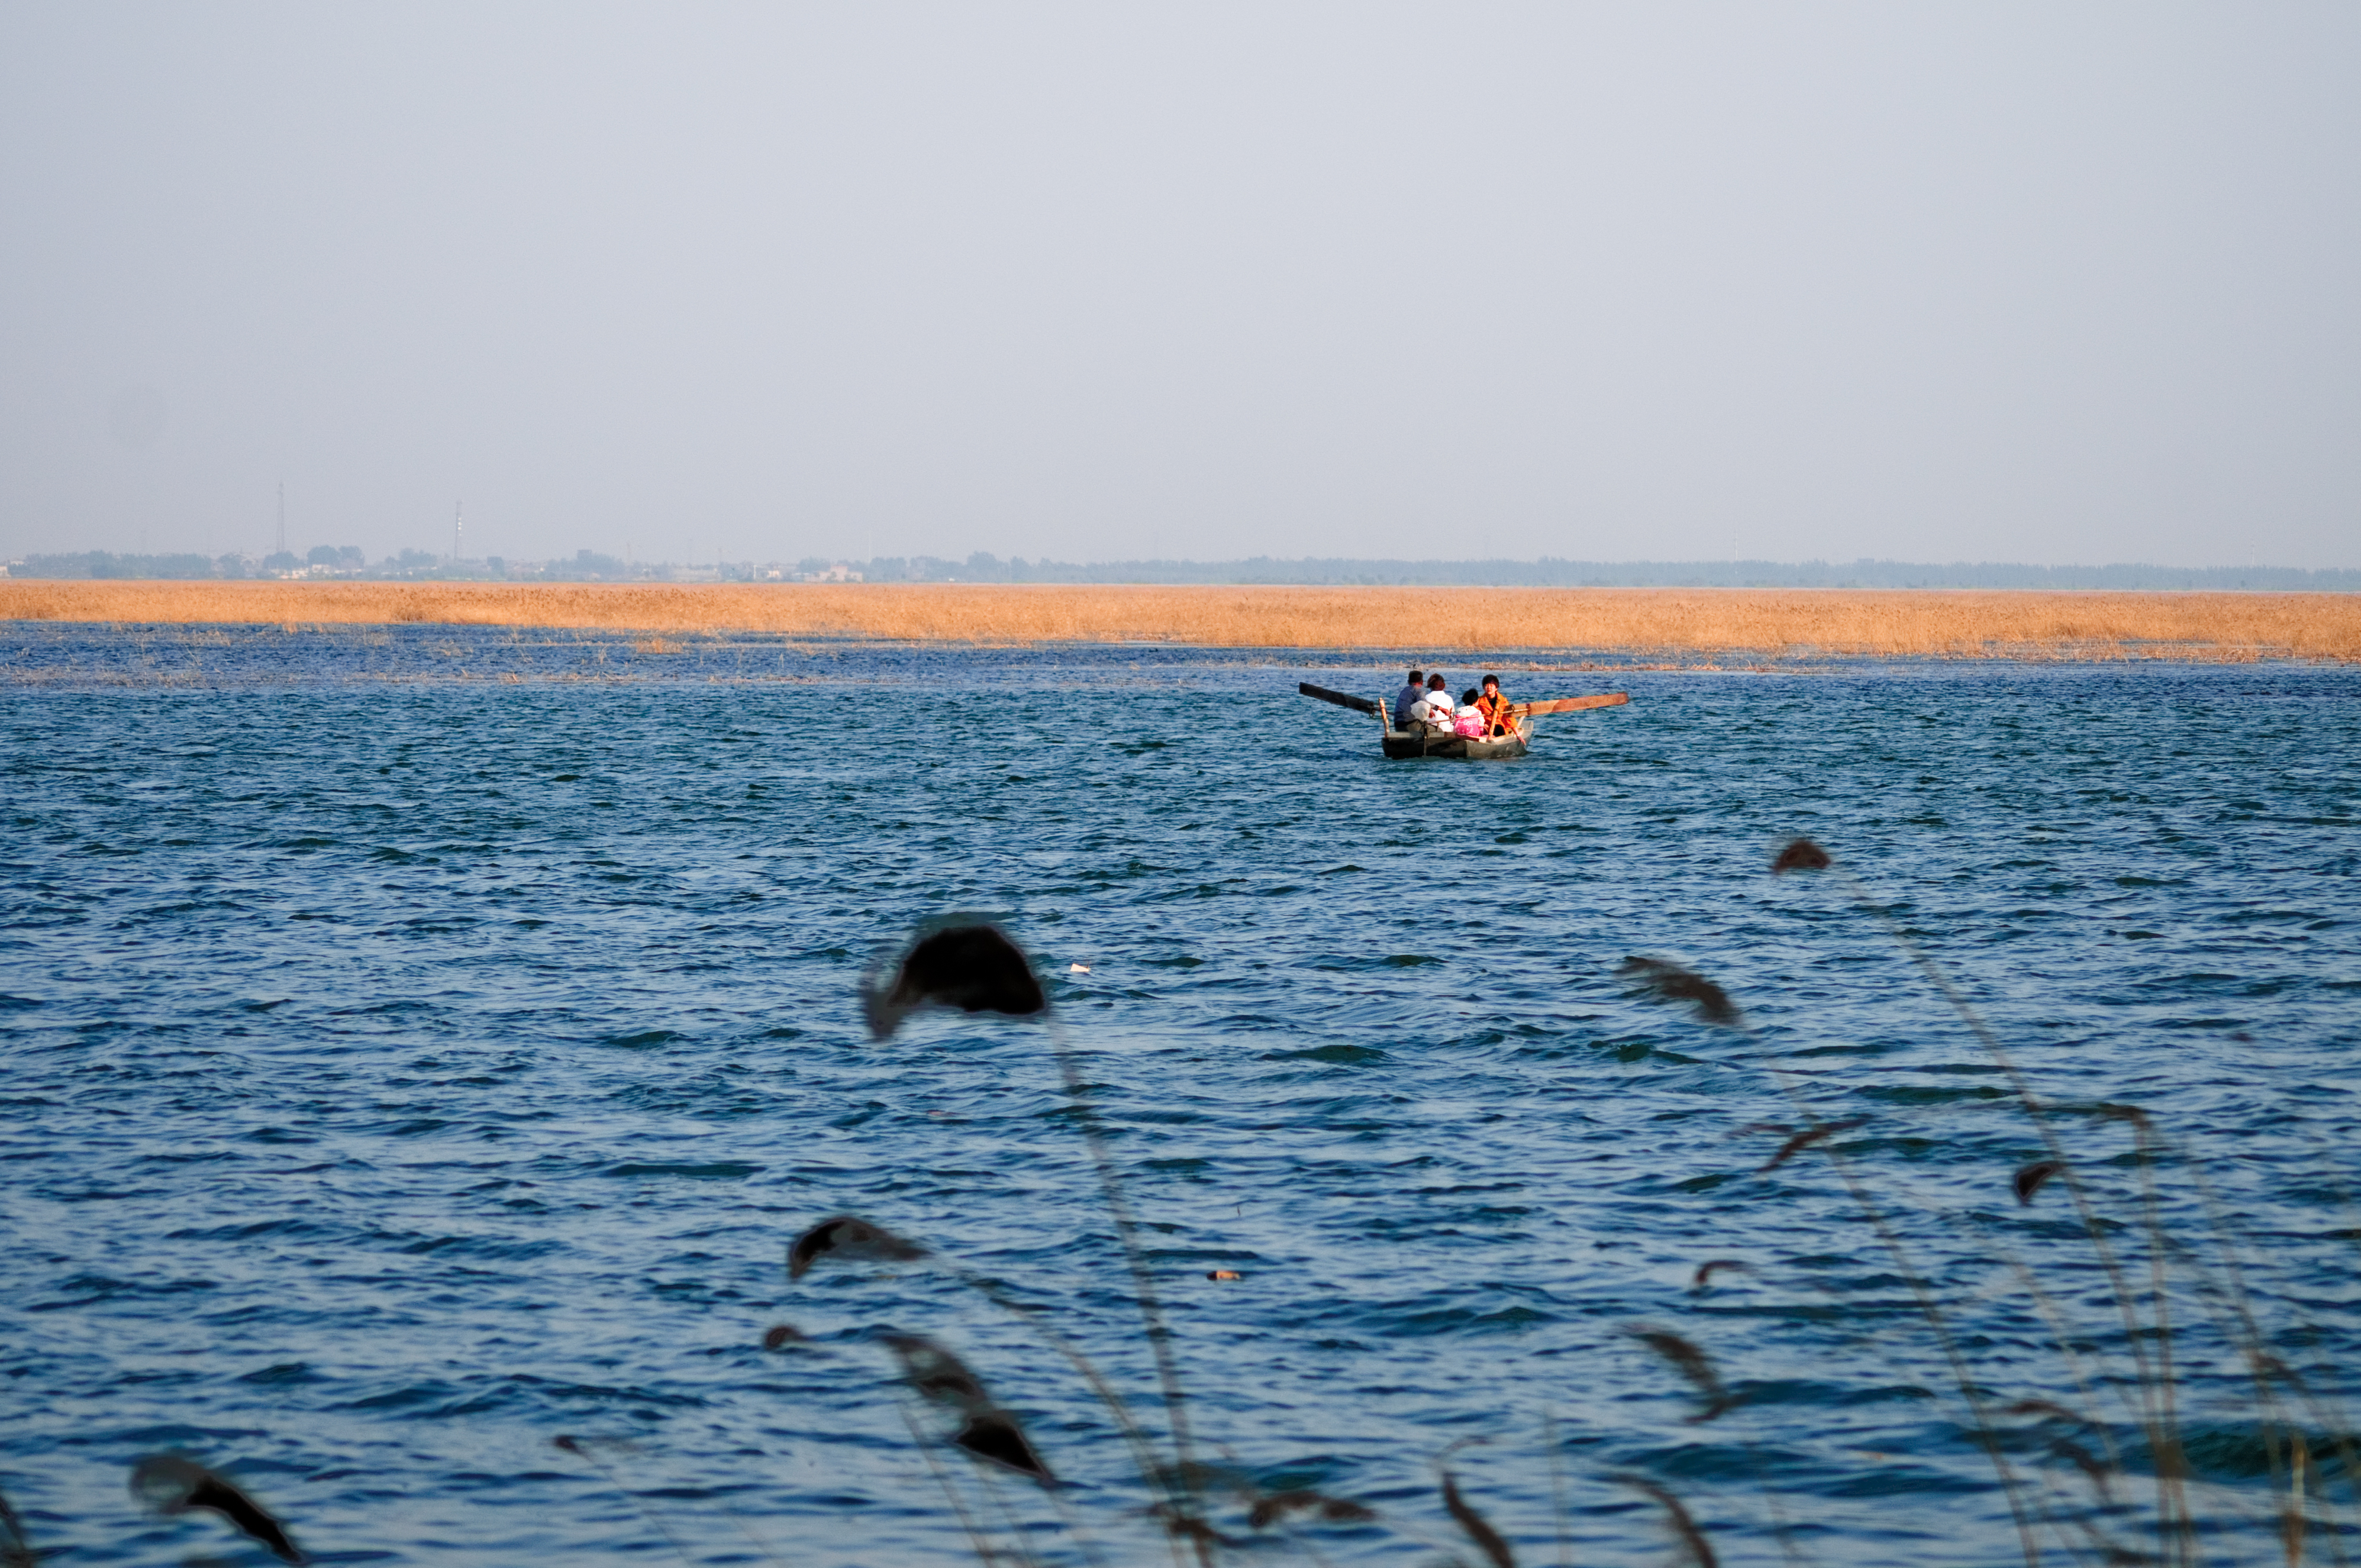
<box><xmin>0</xmin><ymin>0</ymin><xmax>2361</xmax><ymax>567</ymax></box>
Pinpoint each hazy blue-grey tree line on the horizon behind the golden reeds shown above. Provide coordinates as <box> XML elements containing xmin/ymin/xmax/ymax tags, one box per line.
<box><xmin>7</xmin><ymin>546</ymin><xmax>2361</xmax><ymax>593</ymax></box>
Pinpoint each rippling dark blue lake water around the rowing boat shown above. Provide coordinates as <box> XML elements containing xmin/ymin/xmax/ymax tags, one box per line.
<box><xmin>0</xmin><ymin>626</ymin><xmax>2361</xmax><ymax>1563</ymax></box>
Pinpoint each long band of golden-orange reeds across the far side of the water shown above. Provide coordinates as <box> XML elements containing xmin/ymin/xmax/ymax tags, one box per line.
<box><xmin>0</xmin><ymin>579</ymin><xmax>2361</xmax><ymax>661</ymax></box>
